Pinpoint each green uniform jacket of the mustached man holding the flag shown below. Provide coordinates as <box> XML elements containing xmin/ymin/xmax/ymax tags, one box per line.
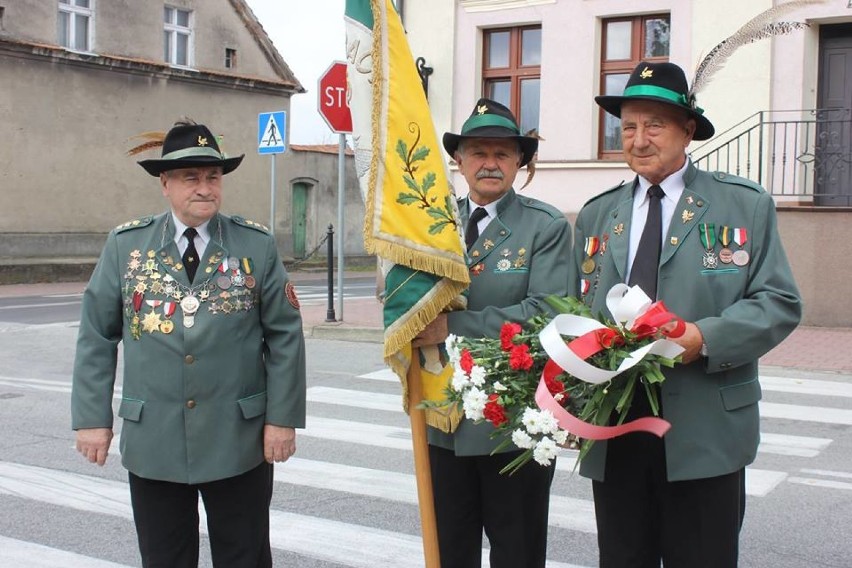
<box><xmin>428</xmin><ymin>190</ymin><xmax>575</xmax><ymax>456</ymax></box>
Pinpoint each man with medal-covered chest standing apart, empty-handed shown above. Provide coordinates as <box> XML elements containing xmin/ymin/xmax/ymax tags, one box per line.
<box><xmin>71</xmin><ymin>122</ymin><xmax>305</xmax><ymax>568</ymax></box>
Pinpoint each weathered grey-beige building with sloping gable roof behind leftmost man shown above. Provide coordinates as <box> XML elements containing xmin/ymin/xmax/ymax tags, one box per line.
<box><xmin>0</xmin><ymin>0</ymin><xmax>307</xmax><ymax>266</ymax></box>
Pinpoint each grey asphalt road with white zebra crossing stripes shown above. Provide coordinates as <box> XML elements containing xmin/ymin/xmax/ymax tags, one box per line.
<box><xmin>0</xmin><ymin>292</ymin><xmax>852</xmax><ymax>568</ymax></box>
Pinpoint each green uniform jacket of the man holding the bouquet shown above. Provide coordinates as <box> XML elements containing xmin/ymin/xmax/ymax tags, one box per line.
<box><xmin>574</xmin><ymin>164</ymin><xmax>802</xmax><ymax>481</ymax></box>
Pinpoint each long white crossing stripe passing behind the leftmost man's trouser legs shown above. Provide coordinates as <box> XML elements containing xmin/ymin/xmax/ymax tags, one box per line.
<box><xmin>0</xmin><ymin>462</ymin><xmax>583</xmax><ymax>568</ymax></box>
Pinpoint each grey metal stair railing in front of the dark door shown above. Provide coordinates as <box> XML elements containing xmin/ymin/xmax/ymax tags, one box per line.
<box><xmin>691</xmin><ymin>108</ymin><xmax>852</xmax><ymax>206</ymax></box>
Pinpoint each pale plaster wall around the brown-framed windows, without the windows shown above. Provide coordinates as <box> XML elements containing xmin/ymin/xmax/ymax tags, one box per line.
<box><xmin>426</xmin><ymin>0</ymin><xmax>852</xmax><ymax>214</ymax></box>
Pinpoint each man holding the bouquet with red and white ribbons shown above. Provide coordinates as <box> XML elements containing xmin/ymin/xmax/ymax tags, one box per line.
<box><xmin>574</xmin><ymin>63</ymin><xmax>802</xmax><ymax>568</ymax></box>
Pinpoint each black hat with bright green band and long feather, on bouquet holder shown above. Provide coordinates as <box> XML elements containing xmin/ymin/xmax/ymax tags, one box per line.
<box><xmin>595</xmin><ymin>61</ymin><xmax>716</xmax><ymax>140</ymax></box>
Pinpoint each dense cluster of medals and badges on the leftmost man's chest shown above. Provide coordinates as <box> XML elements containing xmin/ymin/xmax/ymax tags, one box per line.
<box><xmin>125</xmin><ymin>251</ymin><xmax>256</xmax><ymax>336</ymax></box>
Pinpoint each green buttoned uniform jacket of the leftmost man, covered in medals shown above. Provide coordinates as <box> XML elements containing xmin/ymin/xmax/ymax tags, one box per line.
<box><xmin>71</xmin><ymin>213</ymin><xmax>305</xmax><ymax>484</ymax></box>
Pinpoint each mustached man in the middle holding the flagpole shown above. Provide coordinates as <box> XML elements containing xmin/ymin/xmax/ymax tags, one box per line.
<box><xmin>415</xmin><ymin>99</ymin><xmax>574</xmax><ymax>568</ymax></box>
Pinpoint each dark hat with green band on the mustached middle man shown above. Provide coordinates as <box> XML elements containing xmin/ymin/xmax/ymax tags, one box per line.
<box><xmin>443</xmin><ymin>99</ymin><xmax>538</xmax><ymax>166</ymax></box>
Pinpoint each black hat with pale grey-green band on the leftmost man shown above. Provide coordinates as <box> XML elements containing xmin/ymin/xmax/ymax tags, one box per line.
<box><xmin>139</xmin><ymin>124</ymin><xmax>245</xmax><ymax>176</ymax></box>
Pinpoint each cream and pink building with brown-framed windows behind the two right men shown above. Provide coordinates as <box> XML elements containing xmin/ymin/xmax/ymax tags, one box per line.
<box><xmin>403</xmin><ymin>0</ymin><xmax>852</xmax><ymax>325</ymax></box>
